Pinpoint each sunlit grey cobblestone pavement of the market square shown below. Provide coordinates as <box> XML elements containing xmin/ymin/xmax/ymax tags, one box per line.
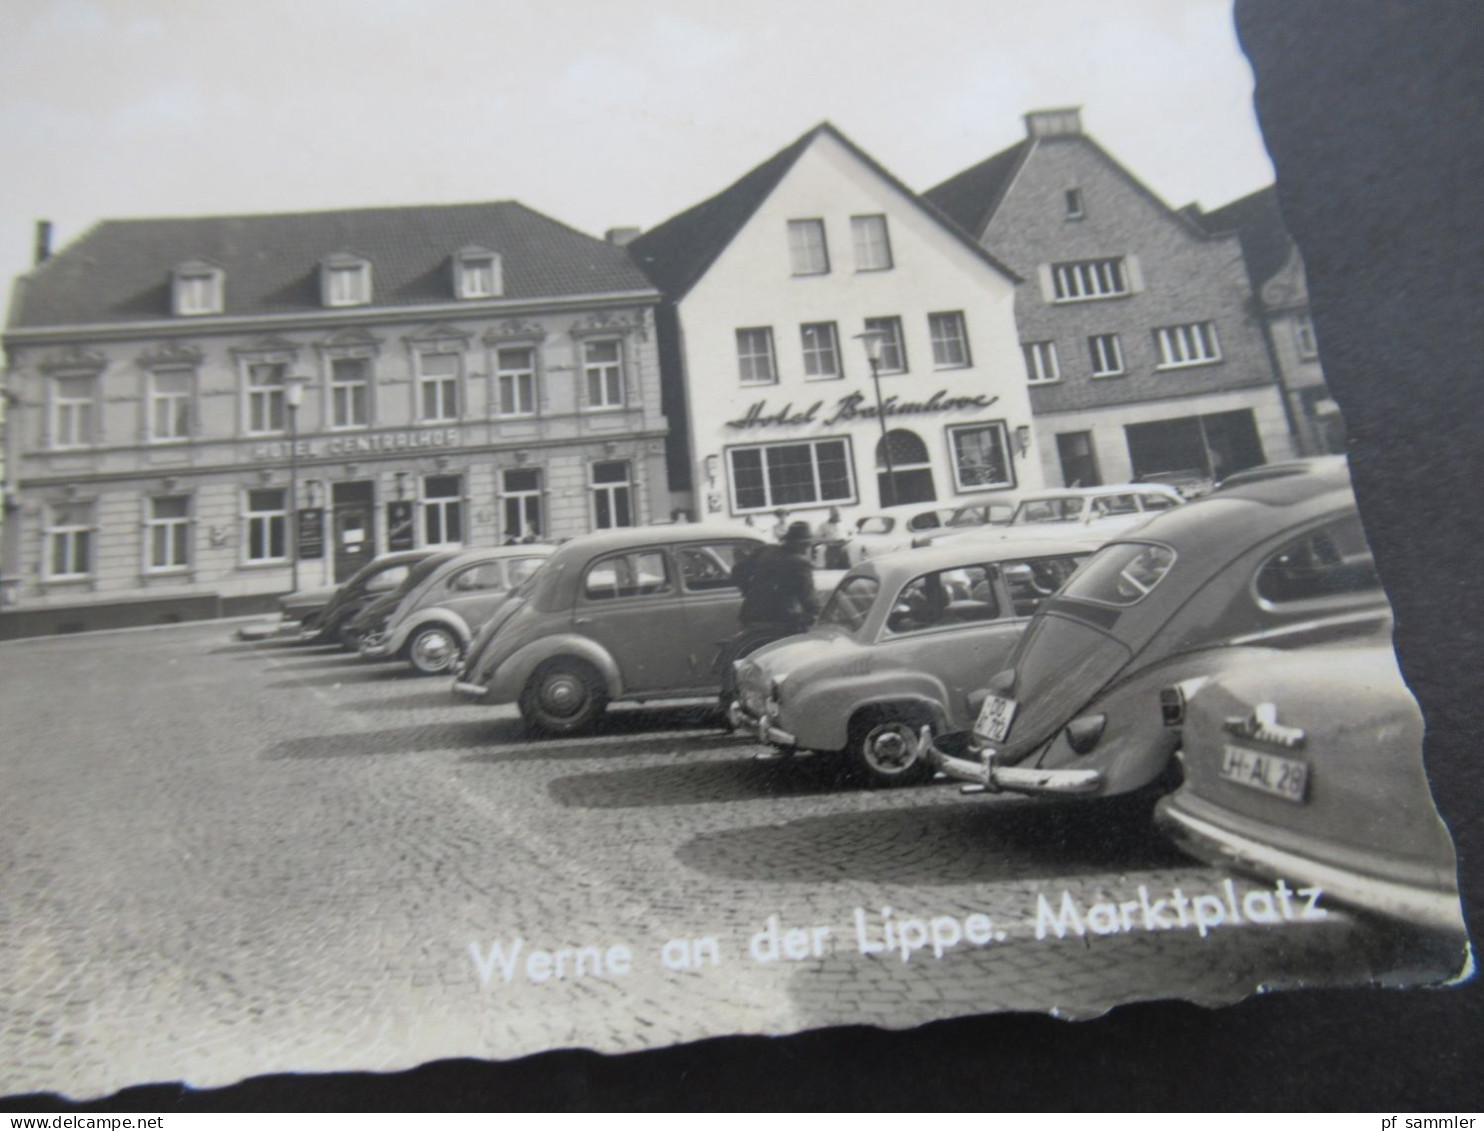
<box><xmin>0</xmin><ymin>625</ymin><xmax>1448</xmax><ymax>1097</ymax></box>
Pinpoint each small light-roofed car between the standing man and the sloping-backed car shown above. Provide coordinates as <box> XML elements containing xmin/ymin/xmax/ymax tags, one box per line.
<box><xmin>729</xmin><ymin>540</ymin><xmax>1092</xmax><ymax>785</ymax></box>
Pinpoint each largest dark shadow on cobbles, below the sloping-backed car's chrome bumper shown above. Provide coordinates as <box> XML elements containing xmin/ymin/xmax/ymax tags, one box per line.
<box><xmin>675</xmin><ymin>794</ymin><xmax>1192</xmax><ymax>886</ymax></box>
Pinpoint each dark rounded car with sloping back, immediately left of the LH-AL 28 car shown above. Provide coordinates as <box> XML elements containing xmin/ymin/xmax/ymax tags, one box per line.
<box><xmin>933</xmin><ymin>457</ymin><xmax>1391</xmax><ymax>796</ymax></box>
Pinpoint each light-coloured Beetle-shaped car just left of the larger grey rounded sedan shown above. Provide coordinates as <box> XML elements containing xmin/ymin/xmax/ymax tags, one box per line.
<box><xmin>361</xmin><ymin>545</ymin><xmax>552</xmax><ymax>675</ymax></box>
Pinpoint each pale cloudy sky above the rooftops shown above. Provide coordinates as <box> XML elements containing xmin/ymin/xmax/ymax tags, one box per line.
<box><xmin>0</xmin><ymin>0</ymin><xmax>1273</xmax><ymax>299</ymax></box>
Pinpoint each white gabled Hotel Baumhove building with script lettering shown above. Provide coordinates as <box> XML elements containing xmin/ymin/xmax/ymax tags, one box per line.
<box><xmin>629</xmin><ymin>123</ymin><xmax>1042</xmax><ymax>522</ymax></box>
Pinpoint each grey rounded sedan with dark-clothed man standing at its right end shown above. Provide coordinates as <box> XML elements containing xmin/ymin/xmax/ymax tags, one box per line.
<box><xmin>454</xmin><ymin>524</ymin><xmax>840</xmax><ymax>735</ymax></box>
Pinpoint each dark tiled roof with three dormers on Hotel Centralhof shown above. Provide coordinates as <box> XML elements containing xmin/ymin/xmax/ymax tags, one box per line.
<box><xmin>10</xmin><ymin>200</ymin><xmax>653</xmax><ymax>330</ymax></box>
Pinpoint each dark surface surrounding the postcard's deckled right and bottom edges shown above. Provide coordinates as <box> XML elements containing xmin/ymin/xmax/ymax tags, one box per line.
<box><xmin>0</xmin><ymin>0</ymin><xmax>1484</xmax><ymax>1113</ymax></box>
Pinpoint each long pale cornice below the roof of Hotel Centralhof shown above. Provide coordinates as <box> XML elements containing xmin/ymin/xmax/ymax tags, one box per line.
<box><xmin>3</xmin><ymin>289</ymin><xmax>662</xmax><ymax>347</ymax></box>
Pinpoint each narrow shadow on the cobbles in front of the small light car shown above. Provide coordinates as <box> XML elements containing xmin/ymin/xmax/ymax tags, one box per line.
<box><xmin>548</xmin><ymin>754</ymin><xmax>855</xmax><ymax>809</ymax></box>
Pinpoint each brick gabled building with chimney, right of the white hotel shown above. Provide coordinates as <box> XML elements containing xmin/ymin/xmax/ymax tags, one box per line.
<box><xmin>925</xmin><ymin>110</ymin><xmax>1293</xmax><ymax>485</ymax></box>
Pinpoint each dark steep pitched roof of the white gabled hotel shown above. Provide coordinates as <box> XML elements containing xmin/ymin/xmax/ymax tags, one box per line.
<box><xmin>629</xmin><ymin>122</ymin><xmax>1020</xmax><ymax>301</ymax></box>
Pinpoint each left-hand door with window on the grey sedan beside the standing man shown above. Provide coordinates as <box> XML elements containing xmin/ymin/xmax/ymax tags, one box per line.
<box><xmin>573</xmin><ymin>546</ymin><xmax>692</xmax><ymax>696</ymax></box>
